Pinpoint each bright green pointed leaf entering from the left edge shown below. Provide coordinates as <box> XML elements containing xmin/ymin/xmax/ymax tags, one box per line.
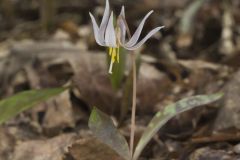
<box><xmin>0</xmin><ymin>88</ymin><xmax>67</xmax><ymax>124</ymax></box>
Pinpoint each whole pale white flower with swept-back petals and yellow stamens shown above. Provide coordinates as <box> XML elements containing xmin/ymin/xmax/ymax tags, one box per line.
<box><xmin>89</xmin><ymin>0</ymin><xmax>163</xmax><ymax>74</ymax></box>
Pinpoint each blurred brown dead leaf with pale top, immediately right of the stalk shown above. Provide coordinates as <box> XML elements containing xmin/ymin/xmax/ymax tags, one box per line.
<box><xmin>137</xmin><ymin>63</ymin><xmax>172</xmax><ymax>113</ymax></box>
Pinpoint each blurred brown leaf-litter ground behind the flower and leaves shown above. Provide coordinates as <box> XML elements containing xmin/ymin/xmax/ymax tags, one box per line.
<box><xmin>0</xmin><ymin>0</ymin><xmax>240</xmax><ymax>160</ymax></box>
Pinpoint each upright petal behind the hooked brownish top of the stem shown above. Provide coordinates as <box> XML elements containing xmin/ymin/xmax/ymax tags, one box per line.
<box><xmin>118</xmin><ymin>6</ymin><xmax>127</xmax><ymax>44</ymax></box>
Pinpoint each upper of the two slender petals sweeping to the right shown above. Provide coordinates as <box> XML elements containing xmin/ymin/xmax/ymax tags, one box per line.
<box><xmin>126</xmin><ymin>10</ymin><xmax>153</xmax><ymax>47</ymax></box>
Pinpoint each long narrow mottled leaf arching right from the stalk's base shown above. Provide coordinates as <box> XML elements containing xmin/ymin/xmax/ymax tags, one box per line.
<box><xmin>133</xmin><ymin>94</ymin><xmax>223</xmax><ymax>160</ymax></box>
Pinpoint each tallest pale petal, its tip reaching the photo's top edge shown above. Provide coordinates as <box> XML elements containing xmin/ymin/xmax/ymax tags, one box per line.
<box><xmin>99</xmin><ymin>0</ymin><xmax>110</xmax><ymax>38</ymax></box>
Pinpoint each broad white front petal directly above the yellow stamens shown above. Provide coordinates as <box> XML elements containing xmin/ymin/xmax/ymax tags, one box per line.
<box><xmin>105</xmin><ymin>12</ymin><xmax>117</xmax><ymax>47</ymax></box>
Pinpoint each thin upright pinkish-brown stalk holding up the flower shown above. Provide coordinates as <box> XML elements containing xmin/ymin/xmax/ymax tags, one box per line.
<box><xmin>130</xmin><ymin>53</ymin><xmax>137</xmax><ymax>157</ymax></box>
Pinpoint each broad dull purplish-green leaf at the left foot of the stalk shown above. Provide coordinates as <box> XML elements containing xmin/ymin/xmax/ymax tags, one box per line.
<box><xmin>88</xmin><ymin>107</ymin><xmax>131</xmax><ymax>160</ymax></box>
